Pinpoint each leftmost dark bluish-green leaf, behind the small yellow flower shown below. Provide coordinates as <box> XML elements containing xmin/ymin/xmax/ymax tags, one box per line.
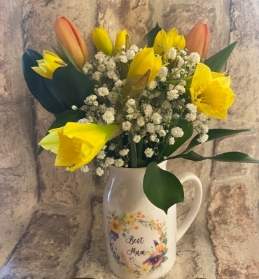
<box><xmin>22</xmin><ymin>49</ymin><xmax>69</xmax><ymax>115</ymax></box>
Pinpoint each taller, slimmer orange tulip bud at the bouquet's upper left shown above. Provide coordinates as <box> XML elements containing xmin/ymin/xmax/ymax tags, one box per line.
<box><xmin>55</xmin><ymin>16</ymin><xmax>88</xmax><ymax>69</ymax></box>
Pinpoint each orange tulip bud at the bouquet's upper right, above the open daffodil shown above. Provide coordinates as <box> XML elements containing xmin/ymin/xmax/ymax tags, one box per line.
<box><xmin>185</xmin><ymin>22</ymin><xmax>210</xmax><ymax>59</ymax></box>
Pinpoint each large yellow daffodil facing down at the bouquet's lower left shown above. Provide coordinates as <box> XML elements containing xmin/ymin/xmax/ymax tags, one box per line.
<box><xmin>39</xmin><ymin>122</ymin><xmax>118</xmax><ymax>171</ymax></box>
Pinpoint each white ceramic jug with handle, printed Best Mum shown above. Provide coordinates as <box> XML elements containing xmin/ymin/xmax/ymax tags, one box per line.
<box><xmin>103</xmin><ymin>162</ymin><xmax>202</xmax><ymax>279</ymax></box>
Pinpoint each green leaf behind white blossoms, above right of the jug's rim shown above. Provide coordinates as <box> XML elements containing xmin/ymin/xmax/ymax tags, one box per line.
<box><xmin>159</xmin><ymin>119</ymin><xmax>193</xmax><ymax>158</ymax></box>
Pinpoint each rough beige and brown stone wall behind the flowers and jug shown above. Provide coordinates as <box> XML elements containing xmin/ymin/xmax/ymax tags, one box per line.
<box><xmin>0</xmin><ymin>0</ymin><xmax>259</xmax><ymax>279</ymax></box>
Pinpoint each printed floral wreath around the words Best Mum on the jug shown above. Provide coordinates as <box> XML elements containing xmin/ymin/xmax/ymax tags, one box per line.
<box><xmin>107</xmin><ymin>211</ymin><xmax>168</xmax><ymax>278</ymax></box>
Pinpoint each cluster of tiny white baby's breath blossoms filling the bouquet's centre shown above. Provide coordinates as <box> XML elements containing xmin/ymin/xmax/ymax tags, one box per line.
<box><xmin>80</xmin><ymin>45</ymin><xmax>208</xmax><ymax>175</ymax></box>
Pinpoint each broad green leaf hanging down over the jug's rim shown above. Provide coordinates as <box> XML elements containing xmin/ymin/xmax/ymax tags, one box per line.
<box><xmin>143</xmin><ymin>162</ymin><xmax>184</xmax><ymax>213</ymax></box>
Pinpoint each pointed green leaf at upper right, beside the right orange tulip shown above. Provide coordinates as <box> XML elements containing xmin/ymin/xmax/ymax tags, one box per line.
<box><xmin>204</xmin><ymin>41</ymin><xmax>237</xmax><ymax>72</ymax></box>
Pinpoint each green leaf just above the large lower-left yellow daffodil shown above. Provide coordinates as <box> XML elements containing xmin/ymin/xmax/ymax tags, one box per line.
<box><xmin>37</xmin><ymin>109</ymin><xmax>85</xmax><ymax>155</ymax></box>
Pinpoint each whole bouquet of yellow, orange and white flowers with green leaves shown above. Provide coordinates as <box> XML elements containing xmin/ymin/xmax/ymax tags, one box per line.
<box><xmin>22</xmin><ymin>17</ymin><xmax>259</xmax><ymax>212</ymax></box>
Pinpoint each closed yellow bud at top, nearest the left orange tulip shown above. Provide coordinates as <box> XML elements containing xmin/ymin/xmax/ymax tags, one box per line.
<box><xmin>92</xmin><ymin>27</ymin><xmax>113</xmax><ymax>56</ymax></box>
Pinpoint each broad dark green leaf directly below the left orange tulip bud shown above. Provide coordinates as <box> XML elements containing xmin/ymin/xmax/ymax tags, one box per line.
<box><xmin>53</xmin><ymin>64</ymin><xmax>94</xmax><ymax>108</ymax></box>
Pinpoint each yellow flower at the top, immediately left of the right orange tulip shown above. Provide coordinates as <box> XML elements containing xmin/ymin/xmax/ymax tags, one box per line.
<box><xmin>153</xmin><ymin>28</ymin><xmax>186</xmax><ymax>54</ymax></box>
